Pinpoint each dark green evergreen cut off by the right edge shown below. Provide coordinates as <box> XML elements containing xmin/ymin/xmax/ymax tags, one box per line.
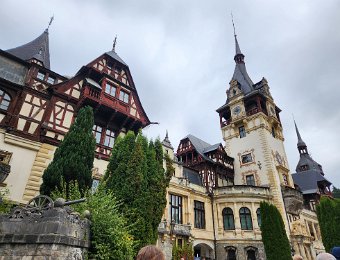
<box><xmin>316</xmin><ymin>197</ymin><xmax>340</xmax><ymax>252</ymax></box>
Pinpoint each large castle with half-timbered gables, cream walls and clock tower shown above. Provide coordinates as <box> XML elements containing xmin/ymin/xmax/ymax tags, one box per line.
<box><xmin>0</xmin><ymin>23</ymin><xmax>332</xmax><ymax>260</ymax></box>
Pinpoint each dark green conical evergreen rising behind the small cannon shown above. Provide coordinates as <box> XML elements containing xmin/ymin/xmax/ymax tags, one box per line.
<box><xmin>40</xmin><ymin>106</ymin><xmax>96</xmax><ymax>198</ymax></box>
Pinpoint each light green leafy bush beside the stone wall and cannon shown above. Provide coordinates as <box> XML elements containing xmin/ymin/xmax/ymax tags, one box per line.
<box><xmin>52</xmin><ymin>181</ymin><xmax>134</xmax><ymax>260</ymax></box>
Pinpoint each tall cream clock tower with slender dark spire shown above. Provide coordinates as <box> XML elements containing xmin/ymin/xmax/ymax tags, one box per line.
<box><xmin>217</xmin><ymin>30</ymin><xmax>294</xmax><ymax>225</ymax></box>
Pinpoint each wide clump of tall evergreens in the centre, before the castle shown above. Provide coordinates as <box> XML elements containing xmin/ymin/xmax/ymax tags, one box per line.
<box><xmin>105</xmin><ymin>132</ymin><xmax>170</xmax><ymax>253</ymax></box>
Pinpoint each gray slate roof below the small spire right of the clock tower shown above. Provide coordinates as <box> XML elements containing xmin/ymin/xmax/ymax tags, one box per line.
<box><xmin>292</xmin><ymin>170</ymin><xmax>331</xmax><ymax>194</ymax></box>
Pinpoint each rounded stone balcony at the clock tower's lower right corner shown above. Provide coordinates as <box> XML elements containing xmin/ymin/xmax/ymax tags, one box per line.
<box><xmin>282</xmin><ymin>186</ymin><xmax>303</xmax><ymax>215</ymax></box>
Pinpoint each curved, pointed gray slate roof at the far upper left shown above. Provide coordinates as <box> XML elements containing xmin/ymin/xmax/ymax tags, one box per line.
<box><xmin>6</xmin><ymin>29</ymin><xmax>50</xmax><ymax>69</ymax></box>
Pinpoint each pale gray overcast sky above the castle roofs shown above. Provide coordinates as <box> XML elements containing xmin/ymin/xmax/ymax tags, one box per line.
<box><xmin>0</xmin><ymin>0</ymin><xmax>340</xmax><ymax>187</ymax></box>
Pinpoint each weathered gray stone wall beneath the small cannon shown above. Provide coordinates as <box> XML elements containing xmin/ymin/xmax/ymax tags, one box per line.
<box><xmin>0</xmin><ymin>204</ymin><xmax>90</xmax><ymax>260</ymax></box>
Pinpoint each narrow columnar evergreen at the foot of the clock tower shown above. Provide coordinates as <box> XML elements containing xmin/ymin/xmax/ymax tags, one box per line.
<box><xmin>260</xmin><ymin>202</ymin><xmax>292</xmax><ymax>260</ymax></box>
